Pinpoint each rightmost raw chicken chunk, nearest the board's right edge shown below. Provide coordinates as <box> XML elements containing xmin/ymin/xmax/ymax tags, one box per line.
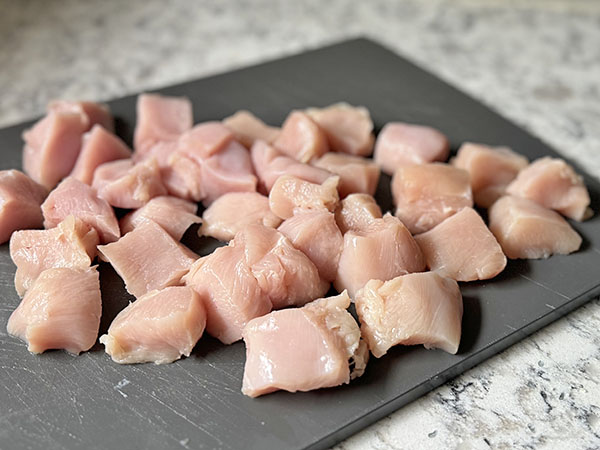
<box><xmin>506</xmin><ymin>157</ymin><xmax>593</xmax><ymax>221</ymax></box>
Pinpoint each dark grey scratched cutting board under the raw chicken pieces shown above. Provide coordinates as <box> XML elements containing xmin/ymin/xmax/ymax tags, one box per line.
<box><xmin>0</xmin><ymin>39</ymin><xmax>600</xmax><ymax>450</ymax></box>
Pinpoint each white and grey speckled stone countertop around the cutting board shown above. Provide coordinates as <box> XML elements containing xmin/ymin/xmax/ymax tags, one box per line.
<box><xmin>0</xmin><ymin>0</ymin><xmax>600</xmax><ymax>450</ymax></box>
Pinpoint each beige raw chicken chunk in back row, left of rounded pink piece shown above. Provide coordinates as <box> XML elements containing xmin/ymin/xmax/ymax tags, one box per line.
<box><xmin>306</xmin><ymin>103</ymin><xmax>375</xmax><ymax>156</ymax></box>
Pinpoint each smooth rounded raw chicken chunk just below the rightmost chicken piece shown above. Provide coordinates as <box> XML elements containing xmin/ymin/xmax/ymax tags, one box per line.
<box><xmin>488</xmin><ymin>195</ymin><xmax>581</xmax><ymax>259</ymax></box>
